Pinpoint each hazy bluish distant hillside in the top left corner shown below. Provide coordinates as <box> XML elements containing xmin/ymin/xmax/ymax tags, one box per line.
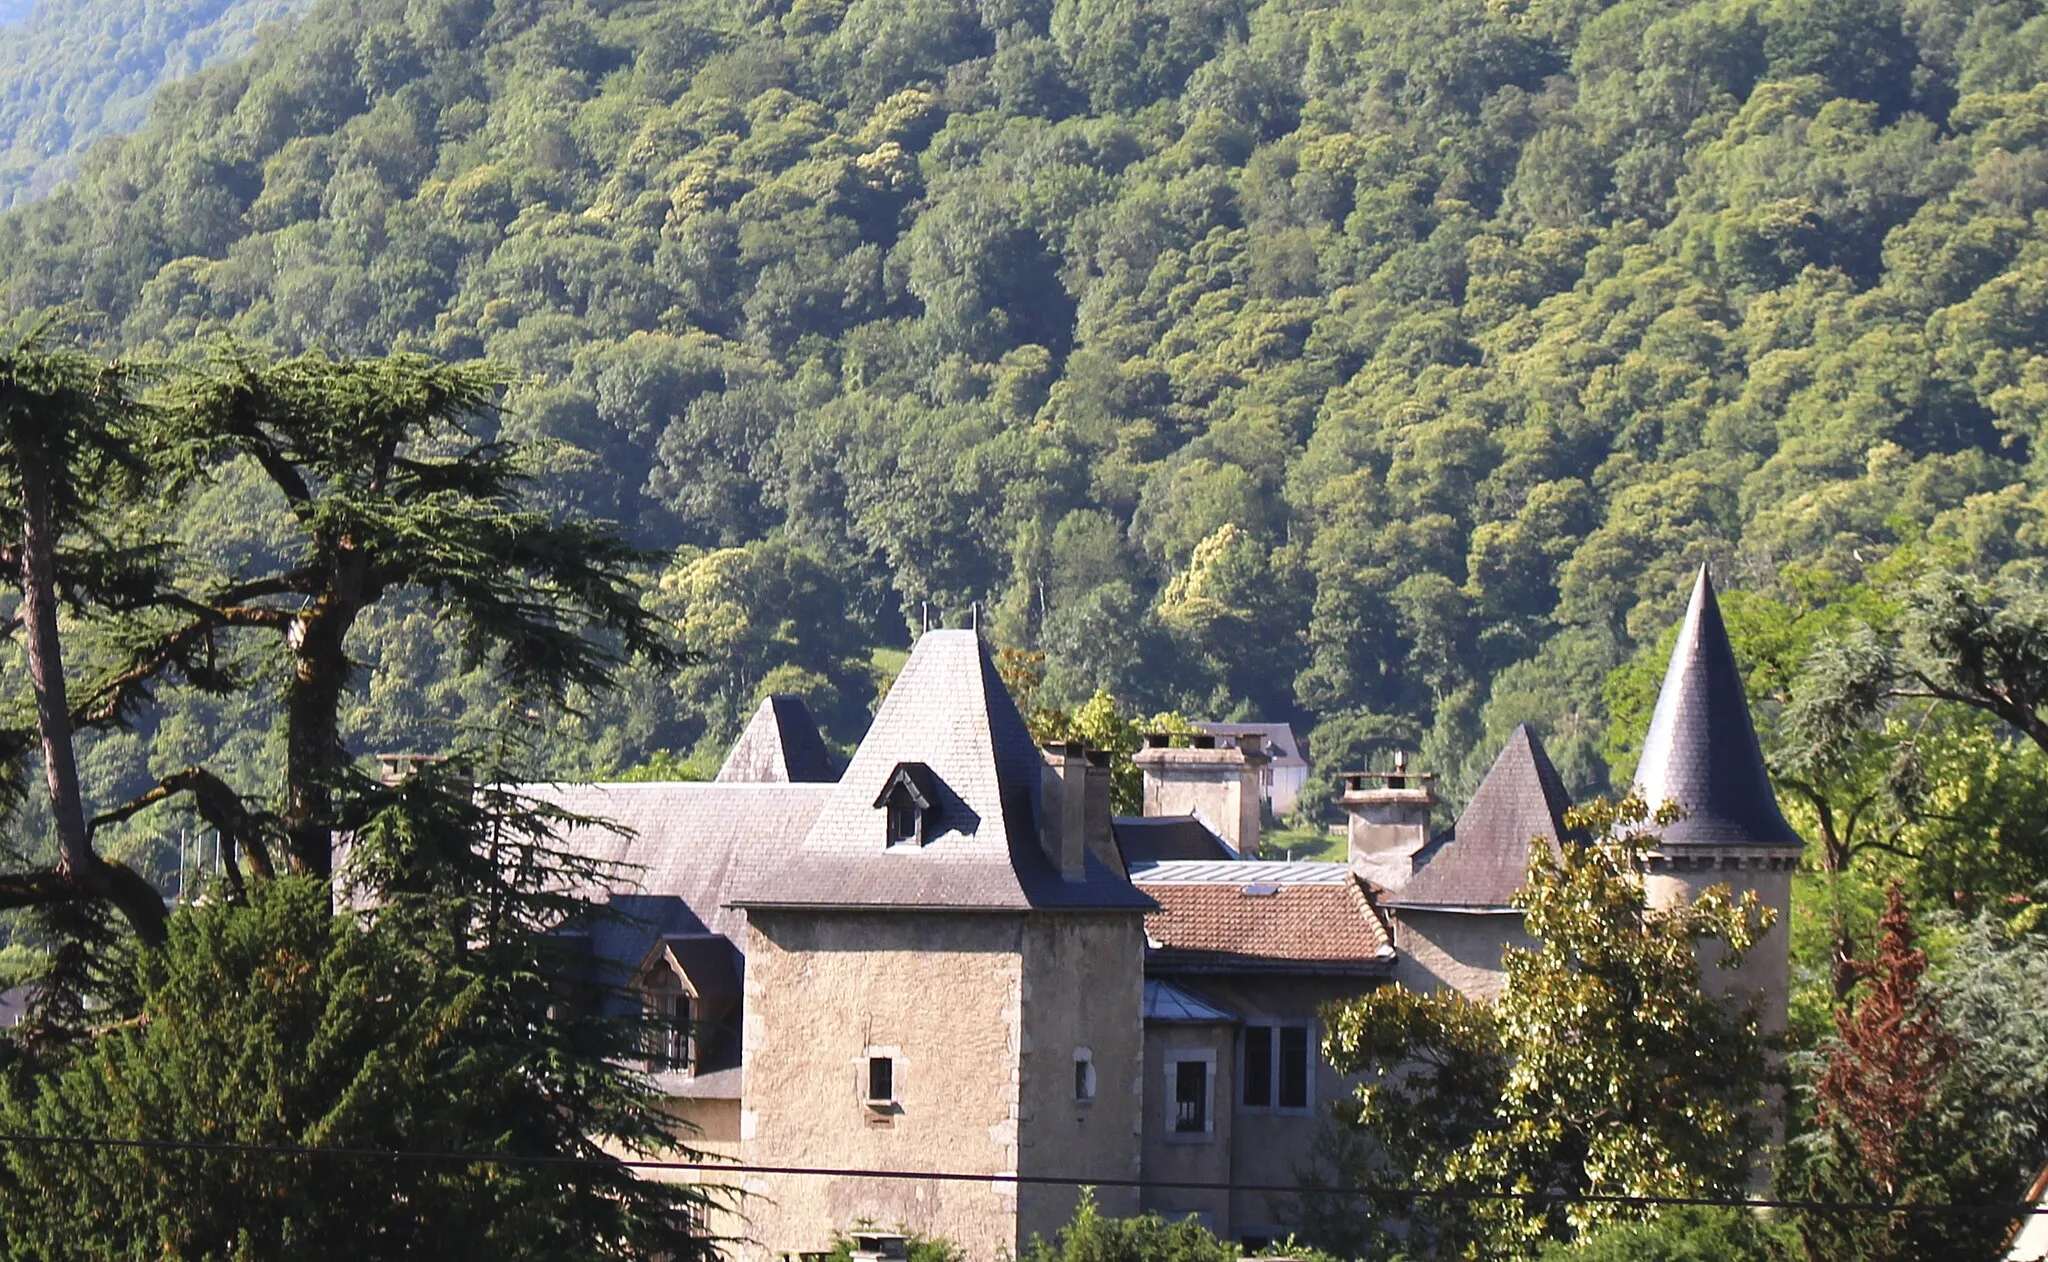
<box><xmin>0</xmin><ymin>0</ymin><xmax>305</xmax><ymax>207</ymax></box>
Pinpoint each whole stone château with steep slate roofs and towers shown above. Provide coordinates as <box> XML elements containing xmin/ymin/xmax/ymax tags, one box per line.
<box><xmin>537</xmin><ymin>572</ymin><xmax>1798</xmax><ymax>1258</ymax></box>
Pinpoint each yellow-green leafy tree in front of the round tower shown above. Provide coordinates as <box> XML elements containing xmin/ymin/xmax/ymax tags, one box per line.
<box><xmin>1305</xmin><ymin>799</ymin><xmax>1769</xmax><ymax>1258</ymax></box>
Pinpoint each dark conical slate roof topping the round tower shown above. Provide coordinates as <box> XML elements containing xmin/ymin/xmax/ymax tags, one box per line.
<box><xmin>1636</xmin><ymin>565</ymin><xmax>1800</xmax><ymax>846</ymax></box>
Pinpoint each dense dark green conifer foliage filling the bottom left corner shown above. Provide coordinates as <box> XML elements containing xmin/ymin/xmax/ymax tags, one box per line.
<box><xmin>0</xmin><ymin>774</ymin><xmax>705</xmax><ymax>1258</ymax></box>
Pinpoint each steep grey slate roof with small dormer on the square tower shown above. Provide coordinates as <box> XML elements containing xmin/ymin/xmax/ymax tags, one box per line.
<box><xmin>727</xmin><ymin>631</ymin><xmax>1151</xmax><ymax>912</ymax></box>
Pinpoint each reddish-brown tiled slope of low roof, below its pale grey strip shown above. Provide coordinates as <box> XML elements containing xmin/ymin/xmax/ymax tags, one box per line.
<box><xmin>1139</xmin><ymin>875</ymin><xmax>1393</xmax><ymax>973</ymax></box>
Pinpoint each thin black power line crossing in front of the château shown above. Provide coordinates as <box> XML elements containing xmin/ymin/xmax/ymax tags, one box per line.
<box><xmin>0</xmin><ymin>1135</ymin><xmax>2048</xmax><ymax>1217</ymax></box>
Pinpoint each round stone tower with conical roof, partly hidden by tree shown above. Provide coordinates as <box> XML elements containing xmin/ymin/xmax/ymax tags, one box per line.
<box><xmin>1636</xmin><ymin>565</ymin><xmax>1802</xmax><ymax>1035</ymax></box>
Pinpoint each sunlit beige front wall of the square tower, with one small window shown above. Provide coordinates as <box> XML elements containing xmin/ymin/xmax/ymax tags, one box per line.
<box><xmin>739</xmin><ymin>910</ymin><xmax>1028</xmax><ymax>1258</ymax></box>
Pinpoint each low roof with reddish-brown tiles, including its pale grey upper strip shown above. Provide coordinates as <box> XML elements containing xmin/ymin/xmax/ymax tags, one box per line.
<box><xmin>1130</xmin><ymin>863</ymin><xmax>1395</xmax><ymax>973</ymax></box>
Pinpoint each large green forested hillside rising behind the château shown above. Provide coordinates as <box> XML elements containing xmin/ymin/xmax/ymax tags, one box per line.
<box><xmin>0</xmin><ymin>0</ymin><xmax>2048</xmax><ymax>819</ymax></box>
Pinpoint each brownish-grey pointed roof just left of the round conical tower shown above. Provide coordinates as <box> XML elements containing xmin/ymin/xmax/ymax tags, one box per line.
<box><xmin>1380</xmin><ymin>723</ymin><xmax>1571</xmax><ymax>912</ymax></box>
